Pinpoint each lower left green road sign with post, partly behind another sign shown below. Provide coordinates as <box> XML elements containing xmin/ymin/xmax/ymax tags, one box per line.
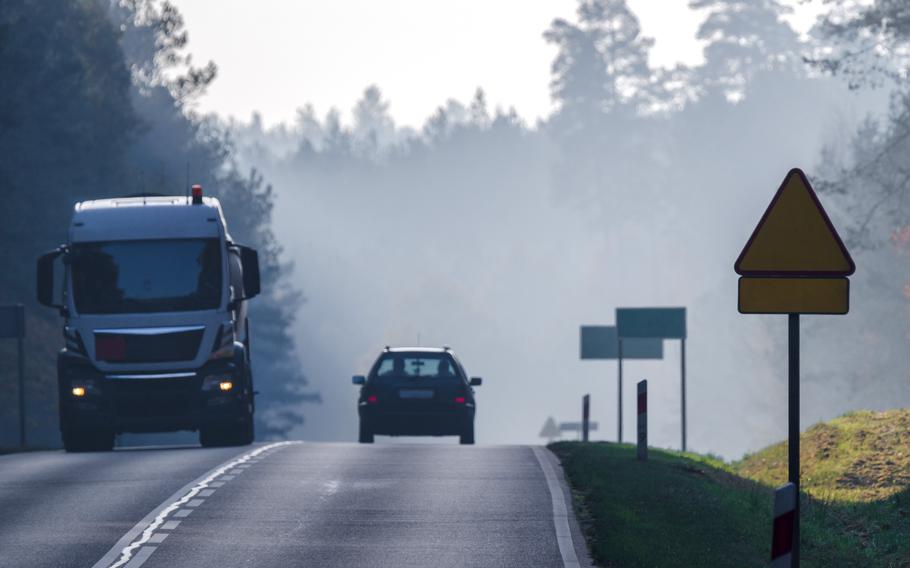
<box><xmin>581</xmin><ymin>325</ymin><xmax>664</xmax><ymax>444</ymax></box>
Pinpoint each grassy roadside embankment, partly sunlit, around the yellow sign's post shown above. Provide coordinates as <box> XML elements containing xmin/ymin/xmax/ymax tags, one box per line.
<box><xmin>550</xmin><ymin>409</ymin><xmax>910</xmax><ymax>568</ymax></box>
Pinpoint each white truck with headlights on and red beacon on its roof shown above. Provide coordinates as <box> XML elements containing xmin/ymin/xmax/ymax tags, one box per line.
<box><xmin>37</xmin><ymin>185</ymin><xmax>259</xmax><ymax>452</ymax></box>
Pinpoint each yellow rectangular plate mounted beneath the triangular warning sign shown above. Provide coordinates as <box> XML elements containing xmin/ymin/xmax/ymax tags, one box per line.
<box><xmin>739</xmin><ymin>277</ymin><xmax>850</xmax><ymax>315</ymax></box>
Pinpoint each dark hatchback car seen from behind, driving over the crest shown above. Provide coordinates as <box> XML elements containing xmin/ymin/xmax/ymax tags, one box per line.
<box><xmin>353</xmin><ymin>347</ymin><xmax>482</xmax><ymax>444</ymax></box>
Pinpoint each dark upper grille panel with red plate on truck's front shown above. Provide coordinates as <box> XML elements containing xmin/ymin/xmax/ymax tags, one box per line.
<box><xmin>95</xmin><ymin>326</ymin><xmax>205</xmax><ymax>363</ymax></box>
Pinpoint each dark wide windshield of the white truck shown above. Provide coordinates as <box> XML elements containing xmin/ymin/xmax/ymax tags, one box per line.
<box><xmin>70</xmin><ymin>239</ymin><xmax>222</xmax><ymax>314</ymax></box>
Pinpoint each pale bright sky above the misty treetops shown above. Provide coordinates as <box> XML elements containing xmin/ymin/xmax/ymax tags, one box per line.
<box><xmin>175</xmin><ymin>0</ymin><xmax>817</xmax><ymax>126</ymax></box>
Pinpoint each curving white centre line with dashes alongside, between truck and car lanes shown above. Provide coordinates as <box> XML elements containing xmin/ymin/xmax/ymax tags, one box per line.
<box><xmin>92</xmin><ymin>442</ymin><xmax>300</xmax><ymax>568</ymax></box>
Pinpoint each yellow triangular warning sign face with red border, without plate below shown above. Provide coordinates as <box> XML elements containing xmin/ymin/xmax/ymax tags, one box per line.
<box><xmin>734</xmin><ymin>168</ymin><xmax>856</xmax><ymax>276</ymax></box>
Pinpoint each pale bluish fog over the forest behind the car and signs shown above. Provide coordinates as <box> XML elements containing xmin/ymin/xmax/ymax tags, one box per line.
<box><xmin>224</xmin><ymin>2</ymin><xmax>910</xmax><ymax>459</ymax></box>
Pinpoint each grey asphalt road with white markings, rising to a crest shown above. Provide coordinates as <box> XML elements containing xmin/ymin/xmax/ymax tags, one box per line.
<box><xmin>0</xmin><ymin>443</ymin><xmax>585</xmax><ymax>568</ymax></box>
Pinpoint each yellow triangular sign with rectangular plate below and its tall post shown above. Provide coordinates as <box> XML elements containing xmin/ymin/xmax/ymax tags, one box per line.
<box><xmin>734</xmin><ymin>168</ymin><xmax>856</xmax><ymax>567</ymax></box>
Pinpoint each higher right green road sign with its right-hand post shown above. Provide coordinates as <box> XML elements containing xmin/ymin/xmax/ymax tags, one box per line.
<box><xmin>616</xmin><ymin>308</ymin><xmax>686</xmax><ymax>451</ymax></box>
